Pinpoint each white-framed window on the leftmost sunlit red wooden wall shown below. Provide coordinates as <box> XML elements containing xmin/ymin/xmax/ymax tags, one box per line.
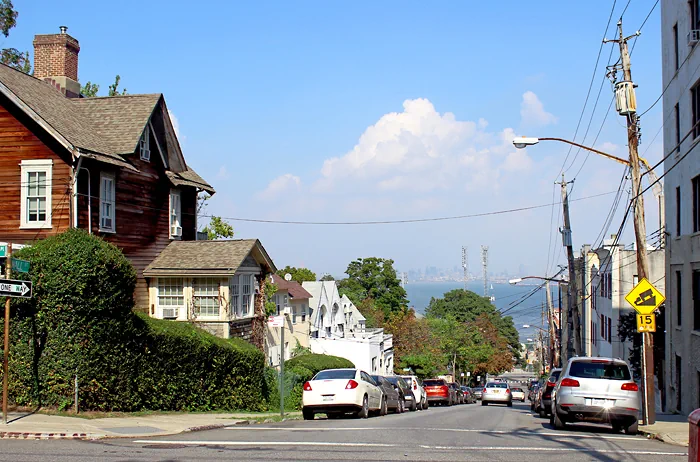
<box><xmin>20</xmin><ymin>159</ymin><xmax>53</xmax><ymax>228</ymax></box>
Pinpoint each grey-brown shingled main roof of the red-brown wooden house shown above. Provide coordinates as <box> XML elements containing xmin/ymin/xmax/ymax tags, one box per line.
<box><xmin>0</xmin><ymin>64</ymin><xmax>214</xmax><ymax>190</ymax></box>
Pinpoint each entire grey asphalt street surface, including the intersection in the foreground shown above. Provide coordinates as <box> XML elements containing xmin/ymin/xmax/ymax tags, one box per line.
<box><xmin>0</xmin><ymin>403</ymin><xmax>687</xmax><ymax>462</ymax></box>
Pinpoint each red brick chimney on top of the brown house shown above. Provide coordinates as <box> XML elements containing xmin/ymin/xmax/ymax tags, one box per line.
<box><xmin>34</xmin><ymin>26</ymin><xmax>80</xmax><ymax>98</ymax></box>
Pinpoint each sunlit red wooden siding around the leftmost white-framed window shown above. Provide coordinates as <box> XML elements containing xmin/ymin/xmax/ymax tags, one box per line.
<box><xmin>0</xmin><ymin>101</ymin><xmax>71</xmax><ymax>244</ymax></box>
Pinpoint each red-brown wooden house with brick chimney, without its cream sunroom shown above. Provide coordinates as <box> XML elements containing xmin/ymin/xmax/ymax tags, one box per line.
<box><xmin>0</xmin><ymin>28</ymin><xmax>214</xmax><ymax>311</ymax></box>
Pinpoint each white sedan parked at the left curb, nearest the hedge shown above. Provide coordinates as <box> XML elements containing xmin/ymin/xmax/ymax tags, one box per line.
<box><xmin>302</xmin><ymin>369</ymin><xmax>387</xmax><ymax>420</ymax></box>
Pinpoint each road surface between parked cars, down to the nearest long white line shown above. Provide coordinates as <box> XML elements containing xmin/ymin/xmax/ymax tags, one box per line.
<box><xmin>130</xmin><ymin>405</ymin><xmax>685</xmax><ymax>459</ymax></box>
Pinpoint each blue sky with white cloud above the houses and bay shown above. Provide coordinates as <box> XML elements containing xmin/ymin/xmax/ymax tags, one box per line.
<box><xmin>12</xmin><ymin>0</ymin><xmax>663</xmax><ymax>277</ymax></box>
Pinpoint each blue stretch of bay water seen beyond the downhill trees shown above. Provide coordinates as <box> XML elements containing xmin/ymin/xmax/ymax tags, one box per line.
<box><xmin>406</xmin><ymin>281</ymin><xmax>558</xmax><ymax>342</ymax></box>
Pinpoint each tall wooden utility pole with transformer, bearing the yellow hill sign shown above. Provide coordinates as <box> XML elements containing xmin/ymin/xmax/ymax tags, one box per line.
<box><xmin>603</xmin><ymin>19</ymin><xmax>656</xmax><ymax>425</ymax></box>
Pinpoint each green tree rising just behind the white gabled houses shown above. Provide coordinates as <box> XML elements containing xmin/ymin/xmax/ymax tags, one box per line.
<box><xmin>338</xmin><ymin>257</ymin><xmax>408</xmax><ymax>316</ymax></box>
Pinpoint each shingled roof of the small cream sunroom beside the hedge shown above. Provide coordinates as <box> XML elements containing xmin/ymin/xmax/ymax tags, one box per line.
<box><xmin>143</xmin><ymin>239</ymin><xmax>276</xmax><ymax>277</ymax></box>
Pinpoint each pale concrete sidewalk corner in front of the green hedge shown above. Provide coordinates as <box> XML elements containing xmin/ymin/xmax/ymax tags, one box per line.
<box><xmin>0</xmin><ymin>412</ymin><xmax>299</xmax><ymax>439</ymax></box>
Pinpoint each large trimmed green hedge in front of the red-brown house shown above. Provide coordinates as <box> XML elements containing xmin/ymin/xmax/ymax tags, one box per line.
<box><xmin>0</xmin><ymin>230</ymin><xmax>264</xmax><ymax>411</ymax></box>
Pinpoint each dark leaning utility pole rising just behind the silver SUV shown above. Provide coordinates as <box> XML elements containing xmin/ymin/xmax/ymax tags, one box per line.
<box><xmin>560</xmin><ymin>173</ymin><xmax>581</xmax><ymax>358</ymax></box>
